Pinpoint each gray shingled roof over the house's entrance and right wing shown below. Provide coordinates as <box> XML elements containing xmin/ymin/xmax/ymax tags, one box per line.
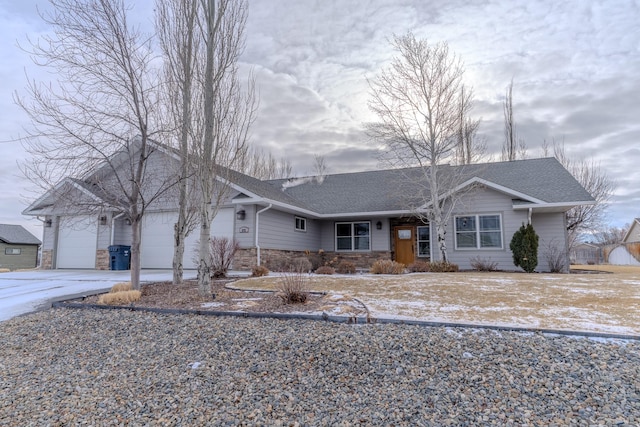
<box><xmin>268</xmin><ymin>158</ymin><xmax>594</xmax><ymax>214</ymax></box>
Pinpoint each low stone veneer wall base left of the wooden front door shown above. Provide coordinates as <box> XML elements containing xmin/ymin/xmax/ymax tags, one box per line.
<box><xmin>233</xmin><ymin>248</ymin><xmax>391</xmax><ymax>270</ymax></box>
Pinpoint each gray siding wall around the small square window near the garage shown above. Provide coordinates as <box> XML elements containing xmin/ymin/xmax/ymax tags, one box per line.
<box><xmin>259</xmin><ymin>209</ymin><xmax>322</xmax><ymax>251</ymax></box>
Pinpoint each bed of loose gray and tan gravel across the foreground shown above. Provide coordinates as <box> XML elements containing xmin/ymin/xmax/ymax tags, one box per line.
<box><xmin>0</xmin><ymin>309</ymin><xmax>640</xmax><ymax>426</ymax></box>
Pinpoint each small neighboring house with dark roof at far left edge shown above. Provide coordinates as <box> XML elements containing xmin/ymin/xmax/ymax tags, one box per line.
<box><xmin>0</xmin><ymin>224</ymin><xmax>41</xmax><ymax>270</ymax></box>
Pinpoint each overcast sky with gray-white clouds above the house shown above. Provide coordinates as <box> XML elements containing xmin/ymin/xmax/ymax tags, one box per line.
<box><xmin>0</xmin><ymin>0</ymin><xmax>640</xmax><ymax>238</ymax></box>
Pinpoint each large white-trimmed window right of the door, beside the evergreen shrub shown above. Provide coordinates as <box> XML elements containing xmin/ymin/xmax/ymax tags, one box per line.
<box><xmin>454</xmin><ymin>214</ymin><xmax>502</xmax><ymax>249</ymax></box>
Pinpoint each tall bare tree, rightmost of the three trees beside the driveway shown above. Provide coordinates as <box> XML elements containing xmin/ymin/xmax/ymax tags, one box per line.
<box><xmin>195</xmin><ymin>0</ymin><xmax>256</xmax><ymax>295</ymax></box>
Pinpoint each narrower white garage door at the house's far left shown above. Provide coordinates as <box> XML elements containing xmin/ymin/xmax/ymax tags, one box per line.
<box><xmin>56</xmin><ymin>216</ymin><xmax>98</xmax><ymax>268</ymax></box>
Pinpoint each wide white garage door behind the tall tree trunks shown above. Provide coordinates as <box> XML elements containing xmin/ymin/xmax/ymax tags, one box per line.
<box><xmin>140</xmin><ymin>208</ymin><xmax>234</xmax><ymax>268</ymax></box>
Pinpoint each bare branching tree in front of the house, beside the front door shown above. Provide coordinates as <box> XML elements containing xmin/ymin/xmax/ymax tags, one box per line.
<box><xmin>366</xmin><ymin>33</ymin><xmax>471</xmax><ymax>261</ymax></box>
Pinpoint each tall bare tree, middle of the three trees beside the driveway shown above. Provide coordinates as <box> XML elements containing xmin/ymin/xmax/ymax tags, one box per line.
<box><xmin>156</xmin><ymin>0</ymin><xmax>204</xmax><ymax>284</ymax></box>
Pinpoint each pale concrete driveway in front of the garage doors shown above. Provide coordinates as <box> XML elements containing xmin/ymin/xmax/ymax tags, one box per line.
<box><xmin>0</xmin><ymin>270</ymin><xmax>197</xmax><ymax>322</ymax></box>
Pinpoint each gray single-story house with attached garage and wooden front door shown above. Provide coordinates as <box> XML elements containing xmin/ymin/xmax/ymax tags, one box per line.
<box><xmin>24</xmin><ymin>142</ymin><xmax>594</xmax><ymax>271</ymax></box>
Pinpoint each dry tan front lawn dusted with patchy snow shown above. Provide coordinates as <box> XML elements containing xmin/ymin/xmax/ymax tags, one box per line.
<box><xmin>234</xmin><ymin>270</ymin><xmax>640</xmax><ymax>334</ymax></box>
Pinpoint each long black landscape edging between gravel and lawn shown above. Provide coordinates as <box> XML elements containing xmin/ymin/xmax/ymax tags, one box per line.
<box><xmin>51</xmin><ymin>301</ymin><xmax>640</xmax><ymax>341</ymax></box>
